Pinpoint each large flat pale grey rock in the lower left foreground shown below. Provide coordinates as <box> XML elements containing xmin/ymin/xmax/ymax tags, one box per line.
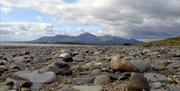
<box><xmin>14</xmin><ymin>70</ymin><xmax>56</xmax><ymax>91</ymax></box>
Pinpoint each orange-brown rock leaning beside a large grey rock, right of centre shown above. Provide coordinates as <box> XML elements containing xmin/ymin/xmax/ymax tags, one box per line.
<box><xmin>111</xmin><ymin>56</ymin><xmax>137</xmax><ymax>72</ymax></box>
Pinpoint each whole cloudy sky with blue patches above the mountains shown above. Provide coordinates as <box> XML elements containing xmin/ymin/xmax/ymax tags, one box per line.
<box><xmin>0</xmin><ymin>0</ymin><xmax>180</xmax><ymax>41</ymax></box>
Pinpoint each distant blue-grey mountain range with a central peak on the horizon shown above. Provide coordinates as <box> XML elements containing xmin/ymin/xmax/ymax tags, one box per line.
<box><xmin>31</xmin><ymin>32</ymin><xmax>142</xmax><ymax>44</ymax></box>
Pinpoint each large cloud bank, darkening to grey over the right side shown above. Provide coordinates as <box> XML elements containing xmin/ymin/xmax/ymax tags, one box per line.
<box><xmin>0</xmin><ymin>0</ymin><xmax>180</xmax><ymax>39</ymax></box>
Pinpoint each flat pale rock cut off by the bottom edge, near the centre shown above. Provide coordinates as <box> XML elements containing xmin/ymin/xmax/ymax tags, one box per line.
<box><xmin>72</xmin><ymin>86</ymin><xmax>103</xmax><ymax>91</ymax></box>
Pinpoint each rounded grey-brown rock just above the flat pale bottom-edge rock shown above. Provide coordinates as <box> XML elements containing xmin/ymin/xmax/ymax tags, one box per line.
<box><xmin>94</xmin><ymin>75</ymin><xmax>111</xmax><ymax>85</ymax></box>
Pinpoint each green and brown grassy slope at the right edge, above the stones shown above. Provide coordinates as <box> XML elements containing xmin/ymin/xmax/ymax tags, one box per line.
<box><xmin>139</xmin><ymin>36</ymin><xmax>180</xmax><ymax>47</ymax></box>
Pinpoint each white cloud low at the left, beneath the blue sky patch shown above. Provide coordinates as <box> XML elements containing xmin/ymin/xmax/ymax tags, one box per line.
<box><xmin>0</xmin><ymin>22</ymin><xmax>55</xmax><ymax>41</ymax></box>
